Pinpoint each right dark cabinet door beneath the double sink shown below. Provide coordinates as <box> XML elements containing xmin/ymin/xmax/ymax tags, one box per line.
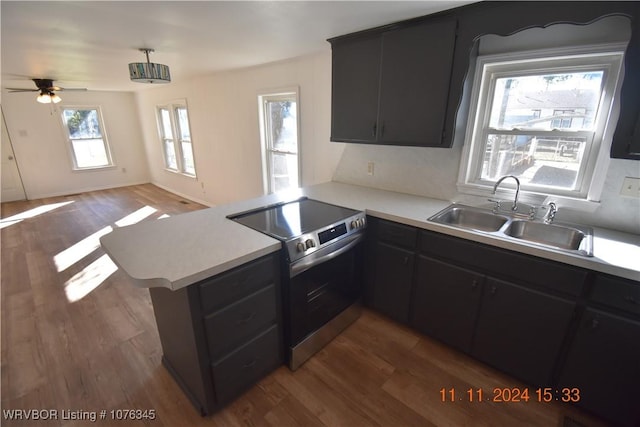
<box><xmin>472</xmin><ymin>278</ymin><xmax>575</xmax><ymax>387</ymax></box>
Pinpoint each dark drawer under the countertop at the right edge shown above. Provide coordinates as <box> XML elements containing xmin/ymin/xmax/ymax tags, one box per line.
<box><xmin>591</xmin><ymin>275</ymin><xmax>640</xmax><ymax>315</ymax></box>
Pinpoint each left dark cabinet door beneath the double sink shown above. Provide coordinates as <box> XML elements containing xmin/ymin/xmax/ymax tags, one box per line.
<box><xmin>411</xmin><ymin>256</ymin><xmax>484</xmax><ymax>353</ymax></box>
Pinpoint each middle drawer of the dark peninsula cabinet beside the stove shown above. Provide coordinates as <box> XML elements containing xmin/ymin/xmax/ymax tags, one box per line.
<box><xmin>204</xmin><ymin>285</ymin><xmax>277</xmax><ymax>360</ymax></box>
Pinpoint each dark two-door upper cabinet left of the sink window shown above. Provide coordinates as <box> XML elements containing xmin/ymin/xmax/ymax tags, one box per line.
<box><xmin>330</xmin><ymin>19</ymin><xmax>456</xmax><ymax>147</ymax></box>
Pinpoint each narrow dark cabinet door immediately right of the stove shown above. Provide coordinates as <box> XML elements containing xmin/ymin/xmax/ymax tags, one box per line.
<box><xmin>367</xmin><ymin>242</ymin><xmax>415</xmax><ymax>323</ymax></box>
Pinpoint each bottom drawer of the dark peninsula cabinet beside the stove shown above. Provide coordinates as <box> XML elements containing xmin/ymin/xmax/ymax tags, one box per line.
<box><xmin>213</xmin><ymin>325</ymin><xmax>282</xmax><ymax>404</ymax></box>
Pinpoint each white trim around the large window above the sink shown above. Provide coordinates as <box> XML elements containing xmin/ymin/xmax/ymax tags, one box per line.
<box><xmin>457</xmin><ymin>43</ymin><xmax>626</xmax><ymax>211</ymax></box>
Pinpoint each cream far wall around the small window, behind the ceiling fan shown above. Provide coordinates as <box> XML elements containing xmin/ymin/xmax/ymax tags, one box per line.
<box><xmin>2</xmin><ymin>91</ymin><xmax>149</xmax><ymax>199</ymax></box>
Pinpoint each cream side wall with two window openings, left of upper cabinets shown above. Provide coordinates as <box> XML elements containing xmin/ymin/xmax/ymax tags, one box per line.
<box><xmin>136</xmin><ymin>50</ymin><xmax>343</xmax><ymax>205</ymax></box>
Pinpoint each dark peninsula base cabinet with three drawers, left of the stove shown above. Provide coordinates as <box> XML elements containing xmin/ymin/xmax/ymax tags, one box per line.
<box><xmin>149</xmin><ymin>253</ymin><xmax>283</xmax><ymax>415</ymax></box>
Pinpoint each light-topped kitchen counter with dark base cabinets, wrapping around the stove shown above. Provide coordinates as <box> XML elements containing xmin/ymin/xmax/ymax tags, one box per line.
<box><xmin>101</xmin><ymin>182</ymin><xmax>640</xmax><ymax>422</ymax></box>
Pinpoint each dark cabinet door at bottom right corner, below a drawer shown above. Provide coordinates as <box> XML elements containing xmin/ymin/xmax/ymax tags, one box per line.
<box><xmin>558</xmin><ymin>308</ymin><xmax>640</xmax><ymax>426</ymax></box>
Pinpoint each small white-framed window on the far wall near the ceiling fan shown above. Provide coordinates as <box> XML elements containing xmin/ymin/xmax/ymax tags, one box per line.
<box><xmin>62</xmin><ymin>107</ymin><xmax>113</xmax><ymax>170</ymax></box>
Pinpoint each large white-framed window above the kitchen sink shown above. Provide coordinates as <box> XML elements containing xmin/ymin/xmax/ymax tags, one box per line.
<box><xmin>458</xmin><ymin>44</ymin><xmax>625</xmax><ymax>199</ymax></box>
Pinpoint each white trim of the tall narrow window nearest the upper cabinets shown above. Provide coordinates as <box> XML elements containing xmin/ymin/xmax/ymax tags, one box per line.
<box><xmin>258</xmin><ymin>86</ymin><xmax>303</xmax><ymax>194</ymax></box>
